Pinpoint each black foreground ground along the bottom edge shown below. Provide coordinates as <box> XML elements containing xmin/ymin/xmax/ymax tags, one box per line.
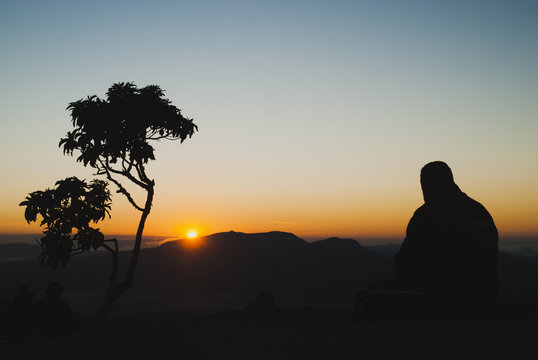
<box><xmin>0</xmin><ymin>304</ymin><xmax>538</xmax><ymax>360</ymax></box>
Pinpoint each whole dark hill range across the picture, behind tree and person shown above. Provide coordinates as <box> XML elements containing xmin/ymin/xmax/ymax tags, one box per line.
<box><xmin>0</xmin><ymin>231</ymin><xmax>538</xmax><ymax>311</ymax></box>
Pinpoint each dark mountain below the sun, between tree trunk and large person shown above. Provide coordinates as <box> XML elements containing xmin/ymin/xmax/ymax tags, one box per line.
<box><xmin>134</xmin><ymin>232</ymin><xmax>392</xmax><ymax>308</ymax></box>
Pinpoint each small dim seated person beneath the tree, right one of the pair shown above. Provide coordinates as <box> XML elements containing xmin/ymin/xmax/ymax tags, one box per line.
<box><xmin>36</xmin><ymin>282</ymin><xmax>72</xmax><ymax>341</ymax></box>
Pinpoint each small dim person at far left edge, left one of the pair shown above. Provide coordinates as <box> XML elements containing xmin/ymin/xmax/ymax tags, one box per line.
<box><xmin>2</xmin><ymin>286</ymin><xmax>34</xmax><ymax>344</ymax></box>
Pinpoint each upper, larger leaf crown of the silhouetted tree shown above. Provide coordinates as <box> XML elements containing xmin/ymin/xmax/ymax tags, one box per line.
<box><xmin>59</xmin><ymin>83</ymin><xmax>198</xmax><ymax>168</ymax></box>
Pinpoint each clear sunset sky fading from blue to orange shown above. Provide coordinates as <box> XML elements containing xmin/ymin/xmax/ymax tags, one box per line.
<box><xmin>0</xmin><ymin>0</ymin><xmax>538</xmax><ymax>239</ymax></box>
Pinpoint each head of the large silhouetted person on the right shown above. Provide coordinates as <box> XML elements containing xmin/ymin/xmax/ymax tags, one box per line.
<box><xmin>420</xmin><ymin>161</ymin><xmax>457</xmax><ymax>202</ymax></box>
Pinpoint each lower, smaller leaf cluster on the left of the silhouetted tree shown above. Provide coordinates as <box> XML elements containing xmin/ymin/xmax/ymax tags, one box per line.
<box><xmin>19</xmin><ymin>177</ymin><xmax>111</xmax><ymax>269</ymax></box>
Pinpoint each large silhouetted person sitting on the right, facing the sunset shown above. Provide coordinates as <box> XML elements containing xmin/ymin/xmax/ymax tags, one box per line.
<box><xmin>394</xmin><ymin>161</ymin><xmax>498</xmax><ymax>314</ymax></box>
